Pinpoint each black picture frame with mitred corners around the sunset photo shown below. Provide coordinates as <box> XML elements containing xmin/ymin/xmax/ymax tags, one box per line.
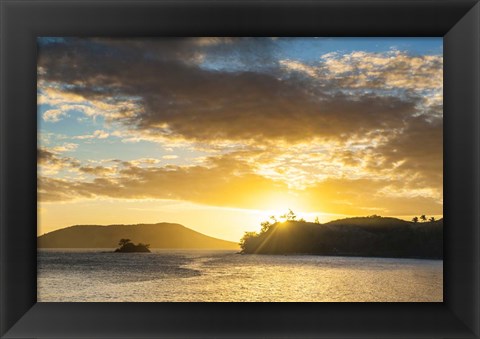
<box><xmin>0</xmin><ymin>0</ymin><xmax>480</xmax><ymax>338</ymax></box>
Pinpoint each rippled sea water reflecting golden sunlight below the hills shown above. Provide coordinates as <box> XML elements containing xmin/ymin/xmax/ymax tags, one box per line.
<box><xmin>38</xmin><ymin>249</ymin><xmax>443</xmax><ymax>302</ymax></box>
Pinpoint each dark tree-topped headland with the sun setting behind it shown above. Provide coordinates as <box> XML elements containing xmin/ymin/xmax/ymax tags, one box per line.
<box><xmin>241</xmin><ymin>216</ymin><xmax>443</xmax><ymax>259</ymax></box>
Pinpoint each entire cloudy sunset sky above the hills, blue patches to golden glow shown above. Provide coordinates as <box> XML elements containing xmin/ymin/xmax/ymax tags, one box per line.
<box><xmin>37</xmin><ymin>37</ymin><xmax>443</xmax><ymax>241</ymax></box>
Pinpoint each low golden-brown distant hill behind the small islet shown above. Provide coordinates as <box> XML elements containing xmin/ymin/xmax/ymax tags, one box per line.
<box><xmin>37</xmin><ymin>223</ymin><xmax>238</xmax><ymax>250</ymax></box>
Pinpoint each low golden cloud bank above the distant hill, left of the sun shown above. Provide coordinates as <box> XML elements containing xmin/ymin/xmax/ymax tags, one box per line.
<box><xmin>39</xmin><ymin>154</ymin><xmax>285</xmax><ymax>207</ymax></box>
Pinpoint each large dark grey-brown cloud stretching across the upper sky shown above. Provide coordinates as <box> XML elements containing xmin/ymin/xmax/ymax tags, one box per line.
<box><xmin>39</xmin><ymin>40</ymin><xmax>432</xmax><ymax>143</ymax></box>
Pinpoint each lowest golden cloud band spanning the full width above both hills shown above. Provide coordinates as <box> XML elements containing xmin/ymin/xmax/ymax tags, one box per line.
<box><xmin>39</xmin><ymin>151</ymin><xmax>441</xmax><ymax>215</ymax></box>
